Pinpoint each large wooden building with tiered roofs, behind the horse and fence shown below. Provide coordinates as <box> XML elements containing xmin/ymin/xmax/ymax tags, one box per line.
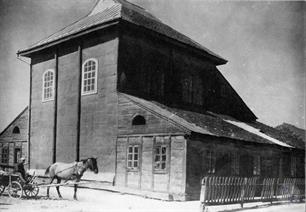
<box><xmin>18</xmin><ymin>0</ymin><xmax>304</xmax><ymax>200</ymax></box>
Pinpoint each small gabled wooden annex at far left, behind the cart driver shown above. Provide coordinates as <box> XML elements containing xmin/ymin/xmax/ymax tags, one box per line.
<box><xmin>0</xmin><ymin>107</ymin><xmax>28</xmax><ymax>167</ymax></box>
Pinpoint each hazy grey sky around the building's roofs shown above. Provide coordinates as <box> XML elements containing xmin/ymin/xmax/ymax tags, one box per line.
<box><xmin>0</xmin><ymin>0</ymin><xmax>306</xmax><ymax>131</ymax></box>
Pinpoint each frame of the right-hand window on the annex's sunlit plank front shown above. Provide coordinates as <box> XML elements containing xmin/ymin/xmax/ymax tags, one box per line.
<box><xmin>153</xmin><ymin>144</ymin><xmax>170</xmax><ymax>174</ymax></box>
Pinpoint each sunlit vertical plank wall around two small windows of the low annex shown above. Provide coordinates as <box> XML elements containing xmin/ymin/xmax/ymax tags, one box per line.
<box><xmin>115</xmin><ymin>135</ymin><xmax>186</xmax><ymax>200</ymax></box>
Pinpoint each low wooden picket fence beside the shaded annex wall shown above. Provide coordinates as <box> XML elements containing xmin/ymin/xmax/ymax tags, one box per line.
<box><xmin>200</xmin><ymin>177</ymin><xmax>305</xmax><ymax>209</ymax></box>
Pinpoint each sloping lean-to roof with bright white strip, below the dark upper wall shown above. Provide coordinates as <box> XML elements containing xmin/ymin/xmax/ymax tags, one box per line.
<box><xmin>119</xmin><ymin>93</ymin><xmax>305</xmax><ymax>149</ymax></box>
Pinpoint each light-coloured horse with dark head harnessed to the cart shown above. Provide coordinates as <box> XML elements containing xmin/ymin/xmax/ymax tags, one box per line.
<box><xmin>45</xmin><ymin>157</ymin><xmax>99</xmax><ymax>200</ymax></box>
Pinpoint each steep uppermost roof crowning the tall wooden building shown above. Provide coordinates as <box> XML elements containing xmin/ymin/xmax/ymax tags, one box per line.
<box><xmin>17</xmin><ymin>0</ymin><xmax>227</xmax><ymax>64</ymax></box>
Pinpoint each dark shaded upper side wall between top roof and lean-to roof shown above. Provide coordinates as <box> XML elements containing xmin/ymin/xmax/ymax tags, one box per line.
<box><xmin>118</xmin><ymin>22</ymin><xmax>256</xmax><ymax>121</ymax></box>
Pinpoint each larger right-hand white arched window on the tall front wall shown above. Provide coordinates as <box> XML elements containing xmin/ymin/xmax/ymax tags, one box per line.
<box><xmin>82</xmin><ymin>58</ymin><xmax>98</xmax><ymax>95</ymax></box>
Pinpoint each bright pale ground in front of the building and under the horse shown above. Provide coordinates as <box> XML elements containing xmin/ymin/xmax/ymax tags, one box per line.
<box><xmin>0</xmin><ymin>187</ymin><xmax>305</xmax><ymax>212</ymax></box>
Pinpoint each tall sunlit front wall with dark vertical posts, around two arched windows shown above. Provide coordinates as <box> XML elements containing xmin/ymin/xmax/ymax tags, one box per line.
<box><xmin>31</xmin><ymin>28</ymin><xmax>119</xmax><ymax>175</ymax></box>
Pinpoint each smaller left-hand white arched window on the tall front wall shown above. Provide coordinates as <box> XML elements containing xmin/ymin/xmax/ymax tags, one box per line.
<box><xmin>42</xmin><ymin>69</ymin><xmax>55</xmax><ymax>101</ymax></box>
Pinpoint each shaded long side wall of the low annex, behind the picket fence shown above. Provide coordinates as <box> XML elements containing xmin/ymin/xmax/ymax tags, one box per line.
<box><xmin>186</xmin><ymin>136</ymin><xmax>305</xmax><ymax>200</ymax></box>
